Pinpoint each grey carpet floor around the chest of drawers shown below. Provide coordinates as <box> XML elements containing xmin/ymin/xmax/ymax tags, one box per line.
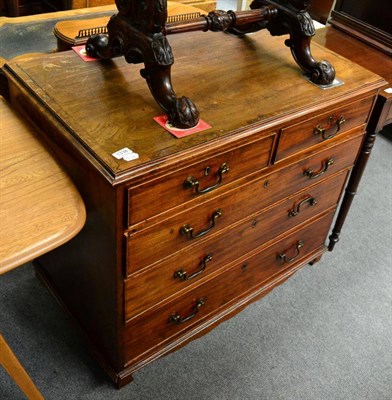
<box><xmin>0</xmin><ymin>127</ymin><xmax>392</xmax><ymax>400</ymax></box>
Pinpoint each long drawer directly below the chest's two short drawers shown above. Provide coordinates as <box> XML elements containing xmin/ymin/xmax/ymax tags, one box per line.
<box><xmin>126</xmin><ymin>136</ymin><xmax>362</xmax><ymax>275</ymax></box>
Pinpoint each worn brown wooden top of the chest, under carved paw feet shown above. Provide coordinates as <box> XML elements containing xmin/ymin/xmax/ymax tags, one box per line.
<box><xmin>5</xmin><ymin>32</ymin><xmax>382</xmax><ymax>182</ymax></box>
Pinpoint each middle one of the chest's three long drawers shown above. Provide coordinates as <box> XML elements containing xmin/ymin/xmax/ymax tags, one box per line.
<box><xmin>125</xmin><ymin>170</ymin><xmax>348</xmax><ymax>320</ymax></box>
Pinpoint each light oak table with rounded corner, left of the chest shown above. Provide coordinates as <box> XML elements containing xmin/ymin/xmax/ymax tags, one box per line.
<box><xmin>0</xmin><ymin>97</ymin><xmax>86</xmax><ymax>400</ymax></box>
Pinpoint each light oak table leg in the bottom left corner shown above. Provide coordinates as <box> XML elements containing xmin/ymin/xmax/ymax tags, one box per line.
<box><xmin>0</xmin><ymin>335</ymin><xmax>44</xmax><ymax>400</ymax></box>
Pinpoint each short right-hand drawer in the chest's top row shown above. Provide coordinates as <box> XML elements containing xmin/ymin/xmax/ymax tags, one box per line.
<box><xmin>275</xmin><ymin>97</ymin><xmax>374</xmax><ymax>161</ymax></box>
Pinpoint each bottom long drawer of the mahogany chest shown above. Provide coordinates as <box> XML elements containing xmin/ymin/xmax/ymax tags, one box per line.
<box><xmin>125</xmin><ymin>213</ymin><xmax>333</xmax><ymax>362</ymax></box>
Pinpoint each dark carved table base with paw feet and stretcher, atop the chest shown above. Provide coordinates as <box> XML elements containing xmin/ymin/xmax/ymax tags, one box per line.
<box><xmin>86</xmin><ymin>0</ymin><xmax>335</xmax><ymax>129</ymax></box>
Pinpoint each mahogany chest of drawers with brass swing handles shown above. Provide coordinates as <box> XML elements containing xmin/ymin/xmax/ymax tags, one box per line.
<box><xmin>3</xmin><ymin>28</ymin><xmax>383</xmax><ymax>386</ymax></box>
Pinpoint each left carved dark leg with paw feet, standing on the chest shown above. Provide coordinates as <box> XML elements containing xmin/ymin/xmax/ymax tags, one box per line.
<box><xmin>86</xmin><ymin>0</ymin><xmax>199</xmax><ymax>129</ymax></box>
